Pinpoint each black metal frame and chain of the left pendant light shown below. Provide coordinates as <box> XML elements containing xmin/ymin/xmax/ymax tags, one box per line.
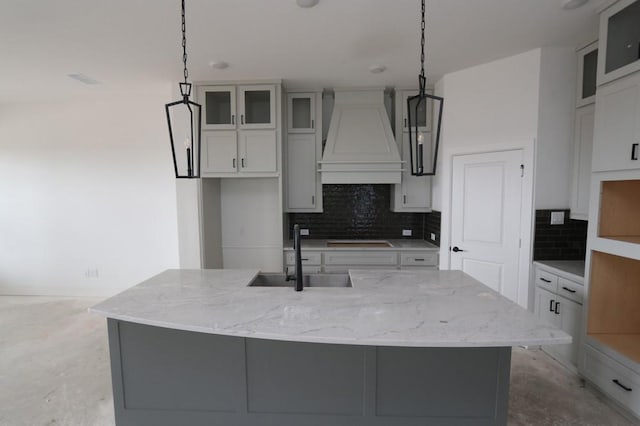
<box><xmin>165</xmin><ymin>0</ymin><xmax>202</xmax><ymax>179</ymax></box>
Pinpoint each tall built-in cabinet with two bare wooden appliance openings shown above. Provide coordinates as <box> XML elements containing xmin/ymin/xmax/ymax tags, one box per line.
<box><xmin>579</xmin><ymin>0</ymin><xmax>640</xmax><ymax>417</ymax></box>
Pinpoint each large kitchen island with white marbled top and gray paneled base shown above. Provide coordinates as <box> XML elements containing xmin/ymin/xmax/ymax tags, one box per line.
<box><xmin>91</xmin><ymin>270</ymin><xmax>571</xmax><ymax>426</ymax></box>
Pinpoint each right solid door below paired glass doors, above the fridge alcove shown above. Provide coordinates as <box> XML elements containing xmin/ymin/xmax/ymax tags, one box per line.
<box><xmin>239</xmin><ymin>130</ymin><xmax>278</xmax><ymax>173</ymax></box>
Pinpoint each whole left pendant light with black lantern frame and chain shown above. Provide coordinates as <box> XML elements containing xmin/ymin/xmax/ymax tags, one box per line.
<box><xmin>165</xmin><ymin>0</ymin><xmax>202</xmax><ymax>179</ymax></box>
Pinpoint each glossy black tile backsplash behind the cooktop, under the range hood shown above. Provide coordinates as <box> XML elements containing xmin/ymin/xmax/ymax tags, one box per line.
<box><xmin>289</xmin><ymin>185</ymin><xmax>428</xmax><ymax>239</ymax></box>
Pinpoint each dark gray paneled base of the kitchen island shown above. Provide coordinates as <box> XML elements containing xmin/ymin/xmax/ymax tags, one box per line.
<box><xmin>108</xmin><ymin>319</ymin><xmax>511</xmax><ymax>426</ymax></box>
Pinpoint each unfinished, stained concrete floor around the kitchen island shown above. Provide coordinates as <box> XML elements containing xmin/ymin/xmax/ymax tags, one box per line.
<box><xmin>0</xmin><ymin>296</ymin><xmax>632</xmax><ymax>426</ymax></box>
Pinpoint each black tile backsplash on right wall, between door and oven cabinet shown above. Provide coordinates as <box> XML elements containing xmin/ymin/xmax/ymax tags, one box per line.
<box><xmin>533</xmin><ymin>209</ymin><xmax>587</xmax><ymax>260</ymax></box>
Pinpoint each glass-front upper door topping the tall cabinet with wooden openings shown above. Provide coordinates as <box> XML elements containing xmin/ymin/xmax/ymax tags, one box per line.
<box><xmin>598</xmin><ymin>0</ymin><xmax>640</xmax><ymax>85</ymax></box>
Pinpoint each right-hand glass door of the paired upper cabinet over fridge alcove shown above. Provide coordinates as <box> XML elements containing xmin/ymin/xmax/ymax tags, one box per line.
<box><xmin>238</xmin><ymin>85</ymin><xmax>276</xmax><ymax>129</ymax></box>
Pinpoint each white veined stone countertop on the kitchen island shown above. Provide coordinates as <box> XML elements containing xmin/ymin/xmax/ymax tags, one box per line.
<box><xmin>90</xmin><ymin>269</ymin><xmax>571</xmax><ymax>347</ymax></box>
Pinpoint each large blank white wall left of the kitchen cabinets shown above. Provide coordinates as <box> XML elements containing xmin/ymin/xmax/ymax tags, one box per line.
<box><xmin>0</xmin><ymin>90</ymin><xmax>178</xmax><ymax>295</ymax></box>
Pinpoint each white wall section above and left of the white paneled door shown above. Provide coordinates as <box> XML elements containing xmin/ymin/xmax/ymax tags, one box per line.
<box><xmin>432</xmin><ymin>49</ymin><xmax>541</xmax><ymax>269</ymax></box>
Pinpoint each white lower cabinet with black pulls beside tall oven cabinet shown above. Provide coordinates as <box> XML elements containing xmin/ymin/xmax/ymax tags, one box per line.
<box><xmin>535</xmin><ymin>270</ymin><xmax>582</xmax><ymax>368</ymax></box>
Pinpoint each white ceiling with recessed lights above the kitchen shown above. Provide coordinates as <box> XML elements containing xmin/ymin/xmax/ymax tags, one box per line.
<box><xmin>0</xmin><ymin>0</ymin><xmax>604</xmax><ymax>103</ymax></box>
